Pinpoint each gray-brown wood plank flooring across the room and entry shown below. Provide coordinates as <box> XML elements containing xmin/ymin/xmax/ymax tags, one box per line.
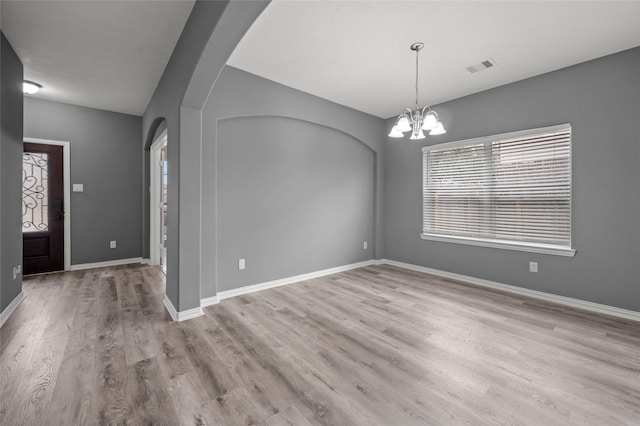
<box><xmin>0</xmin><ymin>266</ymin><xmax>640</xmax><ymax>426</ymax></box>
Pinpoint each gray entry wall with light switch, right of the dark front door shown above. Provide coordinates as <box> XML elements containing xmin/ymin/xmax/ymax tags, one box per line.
<box><xmin>24</xmin><ymin>97</ymin><xmax>142</xmax><ymax>265</ymax></box>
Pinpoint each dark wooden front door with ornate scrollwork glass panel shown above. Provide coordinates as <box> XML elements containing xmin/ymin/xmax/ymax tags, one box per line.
<box><xmin>22</xmin><ymin>143</ymin><xmax>64</xmax><ymax>275</ymax></box>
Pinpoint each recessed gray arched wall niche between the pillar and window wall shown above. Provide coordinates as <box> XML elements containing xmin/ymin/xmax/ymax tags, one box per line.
<box><xmin>218</xmin><ymin>117</ymin><xmax>375</xmax><ymax>291</ymax></box>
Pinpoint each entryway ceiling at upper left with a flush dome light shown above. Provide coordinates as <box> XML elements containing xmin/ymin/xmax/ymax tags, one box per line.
<box><xmin>2</xmin><ymin>0</ymin><xmax>194</xmax><ymax>115</ymax></box>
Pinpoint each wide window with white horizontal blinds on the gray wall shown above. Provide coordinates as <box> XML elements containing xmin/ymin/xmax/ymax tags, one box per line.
<box><xmin>421</xmin><ymin>124</ymin><xmax>575</xmax><ymax>256</ymax></box>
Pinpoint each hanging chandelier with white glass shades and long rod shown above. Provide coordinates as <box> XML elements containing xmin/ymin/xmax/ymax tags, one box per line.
<box><xmin>389</xmin><ymin>42</ymin><xmax>447</xmax><ymax>139</ymax></box>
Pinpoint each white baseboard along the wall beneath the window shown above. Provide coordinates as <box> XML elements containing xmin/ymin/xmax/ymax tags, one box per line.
<box><xmin>376</xmin><ymin>259</ymin><xmax>640</xmax><ymax>321</ymax></box>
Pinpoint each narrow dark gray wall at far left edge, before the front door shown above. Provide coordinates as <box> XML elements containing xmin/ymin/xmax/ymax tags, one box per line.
<box><xmin>0</xmin><ymin>32</ymin><xmax>23</xmax><ymax>312</ymax></box>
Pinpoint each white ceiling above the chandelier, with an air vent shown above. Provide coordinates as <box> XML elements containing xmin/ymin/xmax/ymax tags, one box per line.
<box><xmin>228</xmin><ymin>1</ymin><xmax>640</xmax><ymax>118</ymax></box>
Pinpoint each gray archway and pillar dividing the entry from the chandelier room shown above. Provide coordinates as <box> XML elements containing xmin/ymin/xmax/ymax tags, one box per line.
<box><xmin>142</xmin><ymin>1</ymin><xmax>269</xmax><ymax>311</ymax></box>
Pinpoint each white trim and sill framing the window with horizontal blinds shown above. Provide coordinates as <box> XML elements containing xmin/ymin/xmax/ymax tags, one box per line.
<box><xmin>420</xmin><ymin>123</ymin><xmax>576</xmax><ymax>257</ymax></box>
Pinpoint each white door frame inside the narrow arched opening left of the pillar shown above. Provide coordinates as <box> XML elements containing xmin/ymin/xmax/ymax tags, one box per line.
<box><xmin>149</xmin><ymin>129</ymin><xmax>168</xmax><ymax>265</ymax></box>
